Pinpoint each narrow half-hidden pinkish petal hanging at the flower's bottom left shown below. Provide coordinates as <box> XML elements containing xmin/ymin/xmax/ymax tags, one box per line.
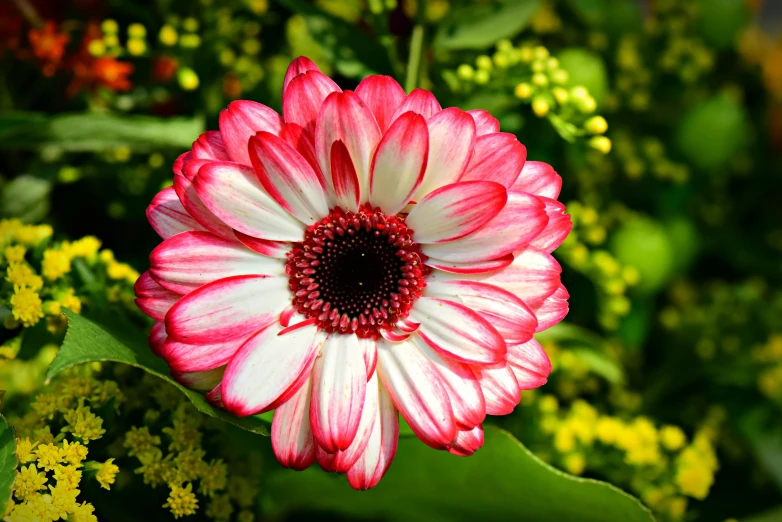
<box><xmin>271</xmin><ymin>372</ymin><xmax>316</xmax><ymax>471</ymax></box>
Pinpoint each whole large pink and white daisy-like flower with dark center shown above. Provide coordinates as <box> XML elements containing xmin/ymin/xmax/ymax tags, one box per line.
<box><xmin>135</xmin><ymin>58</ymin><xmax>571</xmax><ymax>489</ymax></box>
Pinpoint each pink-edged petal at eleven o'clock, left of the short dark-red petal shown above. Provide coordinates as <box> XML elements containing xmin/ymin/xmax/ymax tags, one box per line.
<box><xmin>250</xmin><ymin>132</ymin><xmax>329</xmax><ymax>222</ymax></box>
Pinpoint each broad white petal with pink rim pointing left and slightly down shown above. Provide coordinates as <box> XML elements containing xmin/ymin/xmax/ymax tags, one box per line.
<box><xmin>166</xmin><ymin>275</ymin><xmax>290</xmax><ymax>344</ymax></box>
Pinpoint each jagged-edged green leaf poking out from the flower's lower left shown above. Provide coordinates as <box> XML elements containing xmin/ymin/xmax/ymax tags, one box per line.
<box><xmin>46</xmin><ymin>310</ymin><xmax>269</xmax><ymax>435</ymax></box>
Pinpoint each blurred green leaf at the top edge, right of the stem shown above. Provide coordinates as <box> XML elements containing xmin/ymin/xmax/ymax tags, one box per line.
<box><xmin>434</xmin><ymin>0</ymin><xmax>541</xmax><ymax>49</ymax></box>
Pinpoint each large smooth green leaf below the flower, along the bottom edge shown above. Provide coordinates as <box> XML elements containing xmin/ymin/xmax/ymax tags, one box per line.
<box><xmin>266</xmin><ymin>426</ymin><xmax>654</xmax><ymax>522</ymax></box>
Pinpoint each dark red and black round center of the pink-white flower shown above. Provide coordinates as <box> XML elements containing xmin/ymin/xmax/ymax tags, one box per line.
<box><xmin>285</xmin><ymin>204</ymin><xmax>428</xmax><ymax>339</ymax></box>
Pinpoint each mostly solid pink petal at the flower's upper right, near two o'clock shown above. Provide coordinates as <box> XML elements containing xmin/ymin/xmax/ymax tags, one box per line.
<box><xmin>461</xmin><ymin>132</ymin><xmax>527</xmax><ymax>188</ymax></box>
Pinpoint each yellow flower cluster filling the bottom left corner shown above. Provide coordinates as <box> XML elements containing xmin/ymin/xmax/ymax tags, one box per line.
<box><xmin>3</xmin><ymin>368</ymin><xmax>123</xmax><ymax>522</ymax></box>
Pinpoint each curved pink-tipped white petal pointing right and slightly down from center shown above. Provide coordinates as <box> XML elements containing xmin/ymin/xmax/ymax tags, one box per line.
<box><xmin>425</xmin><ymin>274</ymin><xmax>538</xmax><ymax>345</ymax></box>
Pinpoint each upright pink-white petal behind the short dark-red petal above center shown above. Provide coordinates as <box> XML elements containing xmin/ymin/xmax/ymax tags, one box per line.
<box><xmin>315</xmin><ymin>91</ymin><xmax>381</xmax><ymax>202</ymax></box>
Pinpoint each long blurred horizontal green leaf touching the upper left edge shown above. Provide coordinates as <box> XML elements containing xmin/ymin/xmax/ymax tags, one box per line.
<box><xmin>0</xmin><ymin>112</ymin><xmax>204</xmax><ymax>152</ymax></box>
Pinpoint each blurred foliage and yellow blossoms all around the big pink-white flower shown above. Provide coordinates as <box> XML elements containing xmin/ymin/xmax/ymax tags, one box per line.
<box><xmin>0</xmin><ymin>0</ymin><xmax>782</xmax><ymax>522</ymax></box>
